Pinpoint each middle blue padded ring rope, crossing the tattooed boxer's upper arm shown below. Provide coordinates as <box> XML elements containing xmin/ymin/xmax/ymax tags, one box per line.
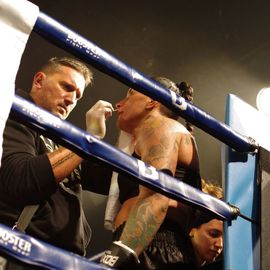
<box><xmin>11</xmin><ymin>96</ymin><xmax>238</xmax><ymax>221</ymax></box>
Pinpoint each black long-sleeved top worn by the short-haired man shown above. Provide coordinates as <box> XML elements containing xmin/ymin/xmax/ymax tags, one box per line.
<box><xmin>0</xmin><ymin>91</ymin><xmax>94</xmax><ymax>255</ymax></box>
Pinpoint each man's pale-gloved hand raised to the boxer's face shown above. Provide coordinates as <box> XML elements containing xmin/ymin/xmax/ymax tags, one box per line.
<box><xmin>86</xmin><ymin>100</ymin><xmax>114</xmax><ymax>139</ymax></box>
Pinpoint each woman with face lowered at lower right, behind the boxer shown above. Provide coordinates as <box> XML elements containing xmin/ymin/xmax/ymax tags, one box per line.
<box><xmin>170</xmin><ymin>179</ymin><xmax>223</xmax><ymax>270</ymax></box>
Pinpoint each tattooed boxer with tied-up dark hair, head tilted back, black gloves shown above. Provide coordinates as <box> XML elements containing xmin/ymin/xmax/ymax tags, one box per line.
<box><xmin>101</xmin><ymin>77</ymin><xmax>204</xmax><ymax>269</ymax></box>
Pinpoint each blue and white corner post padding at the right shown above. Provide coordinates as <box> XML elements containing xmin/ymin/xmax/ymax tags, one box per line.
<box><xmin>224</xmin><ymin>94</ymin><xmax>260</xmax><ymax>270</ymax></box>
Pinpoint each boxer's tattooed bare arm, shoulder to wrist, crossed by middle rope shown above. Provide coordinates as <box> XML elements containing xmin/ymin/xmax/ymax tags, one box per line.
<box><xmin>120</xmin><ymin>117</ymin><xmax>180</xmax><ymax>255</ymax></box>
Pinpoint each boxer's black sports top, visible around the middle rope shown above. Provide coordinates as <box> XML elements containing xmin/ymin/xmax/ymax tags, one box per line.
<box><xmin>118</xmin><ymin>153</ymin><xmax>201</xmax><ymax>204</ymax></box>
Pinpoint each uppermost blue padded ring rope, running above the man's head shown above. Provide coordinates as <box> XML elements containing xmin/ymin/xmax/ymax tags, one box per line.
<box><xmin>34</xmin><ymin>12</ymin><xmax>257</xmax><ymax>152</ymax></box>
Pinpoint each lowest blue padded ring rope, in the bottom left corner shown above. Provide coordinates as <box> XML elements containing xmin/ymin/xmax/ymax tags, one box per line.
<box><xmin>0</xmin><ymin>224</ymin><xmax>111</xmax><ymax>270</ymax></box>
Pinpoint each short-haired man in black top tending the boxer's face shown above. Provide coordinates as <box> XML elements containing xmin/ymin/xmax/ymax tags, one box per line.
<box><xmin>0</xmin><ymin>57</ymin><xmax>113</xmax><ymax>255</ymax></box>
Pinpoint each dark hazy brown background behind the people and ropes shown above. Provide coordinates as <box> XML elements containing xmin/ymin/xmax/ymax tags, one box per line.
<box><xmin>17</xmin><ymin>0</ymin><xmax>270</xmax><ymax>254</ymax></box>
